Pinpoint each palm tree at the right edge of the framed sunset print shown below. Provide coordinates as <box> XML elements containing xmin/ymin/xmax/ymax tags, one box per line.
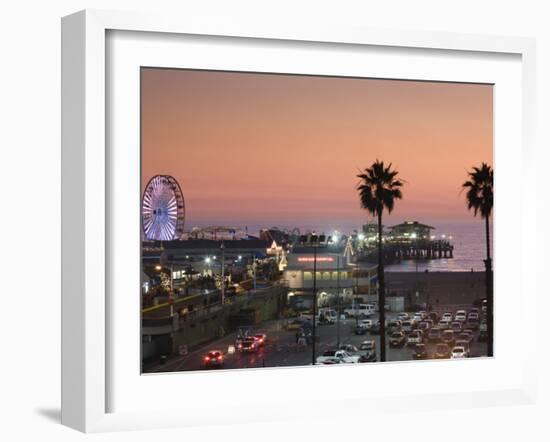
<box><xmin>462</xmin><ymin>163</ymin><xmax>493</xmax><ymax>356</ymax></box>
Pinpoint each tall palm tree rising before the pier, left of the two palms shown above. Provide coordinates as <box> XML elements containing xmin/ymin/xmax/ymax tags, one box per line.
<box><xmin>357</xmin><ymin>160</ymin><xmax>403</xmax><ymax>362</ymax></box>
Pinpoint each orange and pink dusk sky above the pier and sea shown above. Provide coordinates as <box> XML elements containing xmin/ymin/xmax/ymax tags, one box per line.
<box><xmin>141</xmin><ymin>69</ymin><xmax>493</xmax><ymax>230</ymax></box>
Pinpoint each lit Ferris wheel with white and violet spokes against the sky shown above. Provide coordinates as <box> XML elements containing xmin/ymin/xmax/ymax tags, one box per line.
<box><xmin>141</xmin><ymin>175</ymin><xmax>185</xmax><ymax>241</ymax></box>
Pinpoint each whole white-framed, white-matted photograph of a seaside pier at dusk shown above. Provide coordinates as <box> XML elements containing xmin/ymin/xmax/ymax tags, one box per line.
<box><xmin>62</xmin><ymin>11</ymin><xmax>536</xmax><ymax>432</ymax></box>
